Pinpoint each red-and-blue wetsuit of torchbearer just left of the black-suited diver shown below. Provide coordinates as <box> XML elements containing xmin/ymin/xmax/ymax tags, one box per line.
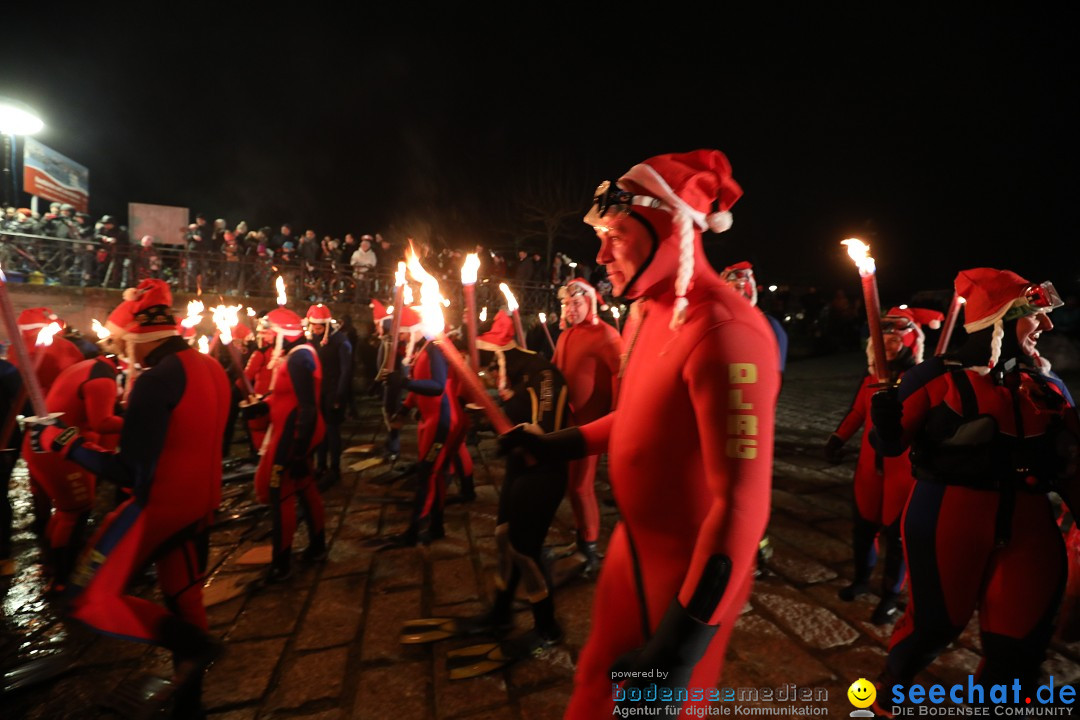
<box><xmin>404</xmin><ymin>342</ymin><xmax>471</xmax><ymax>529</ymax></box>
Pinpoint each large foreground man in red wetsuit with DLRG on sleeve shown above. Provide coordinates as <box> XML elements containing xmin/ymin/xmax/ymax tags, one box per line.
<box><xmin>503</xmin><ymin>150</ymin><xmax>780</xmax><ymax>720</ymax></box>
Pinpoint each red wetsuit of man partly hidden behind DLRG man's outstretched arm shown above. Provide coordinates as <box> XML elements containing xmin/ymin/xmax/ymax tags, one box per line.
<box><xmin>554</xmin><ymin>317</ymin><xmax>621</xmax><ymax>542</ymax></box>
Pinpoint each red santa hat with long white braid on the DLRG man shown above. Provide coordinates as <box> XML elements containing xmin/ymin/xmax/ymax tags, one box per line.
<box><xmin>585</xmin><ymin>150</ymin><xmax>742</xmax><ymax>329</ymax></box>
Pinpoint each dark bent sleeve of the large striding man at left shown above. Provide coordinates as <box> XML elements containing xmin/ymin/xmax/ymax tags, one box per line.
<box><xmin>67</xmin><ymin>356</ymin><xmax>187</xmax><ymax>503</ymax></box>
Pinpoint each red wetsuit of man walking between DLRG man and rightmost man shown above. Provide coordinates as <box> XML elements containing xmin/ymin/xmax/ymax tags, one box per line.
<box><xmin>834</xmin><ymin>376</ymin><xmax>915</xmax><ymax>595</ymax></box>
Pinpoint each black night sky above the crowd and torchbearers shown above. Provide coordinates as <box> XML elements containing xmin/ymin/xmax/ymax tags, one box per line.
<box><xmin>0</xmin><ymin>3</ymin><xmax>1080</xmax><ymax>302</ymax></box>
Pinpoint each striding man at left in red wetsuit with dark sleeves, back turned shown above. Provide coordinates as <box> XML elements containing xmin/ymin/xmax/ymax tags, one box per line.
<box><xmin>32</xmin><ymin>280</ymin><xmax>229</xmax><ymax>717</ymax></box>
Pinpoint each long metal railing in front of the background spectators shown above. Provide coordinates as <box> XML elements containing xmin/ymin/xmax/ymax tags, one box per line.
<box><xmin>0</xmin><ymin>231</ymin><xmax>558</xmax><ymax>314</ymax></box>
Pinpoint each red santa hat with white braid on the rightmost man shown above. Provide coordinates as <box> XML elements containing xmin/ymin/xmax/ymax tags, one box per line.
<box><xmin>953</xmin><ymin>268</ymin><xmax>1063</xmax><ymax>368</ymax></box>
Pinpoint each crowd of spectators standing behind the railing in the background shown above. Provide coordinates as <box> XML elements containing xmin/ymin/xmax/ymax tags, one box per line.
<box><xmin>0</xmin><ymin>203</ymin><xmax>606</xmax><ymax>302</ymax></box>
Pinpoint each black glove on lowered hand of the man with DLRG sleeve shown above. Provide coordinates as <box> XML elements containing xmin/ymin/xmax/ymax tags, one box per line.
<box><xmin>611</xmin><ymin>598</ymin><xmax>719</xmax><ymax>707</ymax></box>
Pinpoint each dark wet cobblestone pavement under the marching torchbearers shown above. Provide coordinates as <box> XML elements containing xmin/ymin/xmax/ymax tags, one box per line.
<box><xmin>0</xmin><ymin>355</ymin><xmax>1080</xmax><ymax>720</ymax></box>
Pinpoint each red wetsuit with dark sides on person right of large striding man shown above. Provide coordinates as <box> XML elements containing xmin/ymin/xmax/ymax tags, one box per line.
<box><xmin>255</xmin><ymin>341</ymin><xmax>325</xmax><ymax>572</ymax></box>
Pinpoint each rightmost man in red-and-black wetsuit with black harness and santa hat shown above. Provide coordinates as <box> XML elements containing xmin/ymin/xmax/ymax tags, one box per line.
<box><xmin>870</xmin><ymin>268</ymin><xmax>1080</xmax><ymax>708</ymax></box>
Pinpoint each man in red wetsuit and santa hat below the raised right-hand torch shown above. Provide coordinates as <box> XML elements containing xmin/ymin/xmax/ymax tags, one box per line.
<box><xmin>825</xmin><ymin>308</ymin><xmax>943</xmax><ymax>625</ymax></box>
